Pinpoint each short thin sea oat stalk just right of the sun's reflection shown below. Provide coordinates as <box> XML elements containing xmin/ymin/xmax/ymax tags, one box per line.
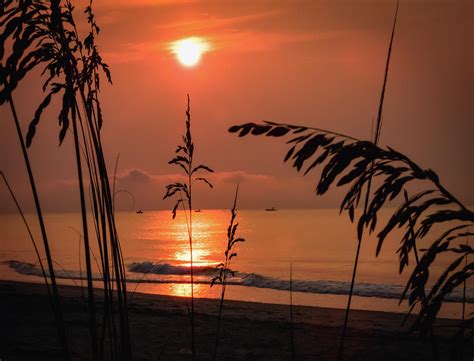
<box><xmin>211</xmin><ymin>184</ymin><xmax>245</xmax><ymax>361</ymax></box>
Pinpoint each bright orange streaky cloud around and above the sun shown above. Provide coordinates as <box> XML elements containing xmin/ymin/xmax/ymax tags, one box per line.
<box><xmin>98</xmin><ymin>2</ymin><xmax>340</xmax><ymax>64</ymax></box>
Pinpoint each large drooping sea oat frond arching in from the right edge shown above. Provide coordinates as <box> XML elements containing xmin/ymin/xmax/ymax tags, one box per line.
<box><xmin>229</xmin><ymin>122</ymin><xmax>474</xmax><ymax>338</ymax></box>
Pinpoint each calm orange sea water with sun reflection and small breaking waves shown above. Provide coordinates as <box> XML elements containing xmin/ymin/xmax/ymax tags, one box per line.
<box><xmin>0</xmin><ymin>209</ymin><xmax>474</xmax><ymax>317</ymax></box>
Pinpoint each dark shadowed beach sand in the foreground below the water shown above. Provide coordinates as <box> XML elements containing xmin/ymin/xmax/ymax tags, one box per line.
<box><xmin>0</xmin><ymin>281</ymin><xmax>474</xmax><ymax>361</ymax></box>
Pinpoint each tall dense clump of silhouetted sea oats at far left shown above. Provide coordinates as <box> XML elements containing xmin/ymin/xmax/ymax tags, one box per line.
<box><xmin>0</xmin><ymin>0</ymin><xmax>131</xmax><ymax>360</ymax></box>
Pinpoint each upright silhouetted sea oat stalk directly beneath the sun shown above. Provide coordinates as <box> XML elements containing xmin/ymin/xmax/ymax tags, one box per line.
<box><xmin>163</xmin><ymin>94</ymin><xmax>214</xmax><ymax>360</ymax></box>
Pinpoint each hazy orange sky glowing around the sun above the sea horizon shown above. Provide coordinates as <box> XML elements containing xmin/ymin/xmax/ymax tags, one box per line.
<box><xmin>0</xmin><ymin>0</ymin><xmax>474</xmax><ymax>212</ymax></box>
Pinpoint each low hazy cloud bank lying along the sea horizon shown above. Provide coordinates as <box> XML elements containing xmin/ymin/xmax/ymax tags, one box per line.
<box><xmin>0</xmin><ymin>168</ymin><xmax>352</xmax><ymax>212</ymax></box>
